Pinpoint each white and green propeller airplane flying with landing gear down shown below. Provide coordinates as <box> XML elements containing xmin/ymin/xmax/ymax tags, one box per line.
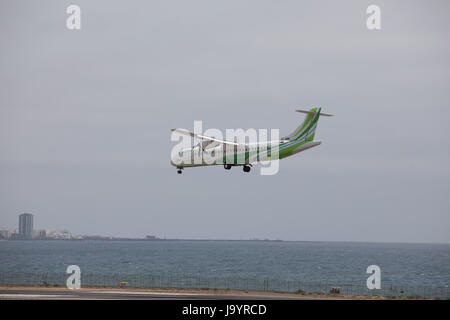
<box><xmin>170</xmin><ymin>107</ymin><xmax>333</xmax><ymax>174</ymax></box>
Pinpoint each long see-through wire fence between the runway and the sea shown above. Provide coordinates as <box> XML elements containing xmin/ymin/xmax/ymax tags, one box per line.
<box><xmin>0</xmin><ymin>272</ymin><xmax>450</xmax><ymax>299</ymax></box>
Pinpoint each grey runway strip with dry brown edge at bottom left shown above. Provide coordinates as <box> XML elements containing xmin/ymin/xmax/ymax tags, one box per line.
<box><xmin>0</xmin><ymin>287</ymin><xmax>314</xmax><ymax>300</ymax></box>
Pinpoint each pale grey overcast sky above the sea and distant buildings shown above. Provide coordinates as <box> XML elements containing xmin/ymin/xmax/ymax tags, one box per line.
<box><xmin>0</xmin><ymin>0</ymin><xmax>450</xmax><ymax>243</ymax></box>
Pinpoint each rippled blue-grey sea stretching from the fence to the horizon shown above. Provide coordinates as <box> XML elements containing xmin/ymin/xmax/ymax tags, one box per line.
<box><xmin>0</xmin><ymin>240</ymin><xmax>450</xmax><ymax>296</ymax></box>
